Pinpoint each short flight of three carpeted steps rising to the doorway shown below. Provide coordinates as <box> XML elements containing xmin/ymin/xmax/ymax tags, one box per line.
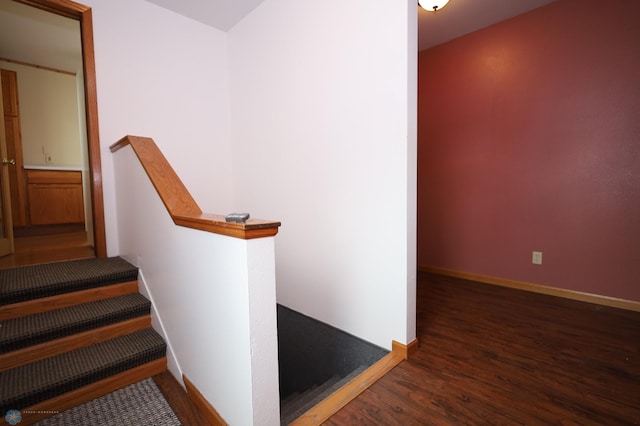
<box><xmin>0</xmin><ymin>257</ymin><xmax>166</xmax><ymax>425</ymax></box>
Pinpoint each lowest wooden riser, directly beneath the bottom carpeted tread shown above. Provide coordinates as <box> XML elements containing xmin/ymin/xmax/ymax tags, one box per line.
<box><xmin>20</xmin><ymin>357</ymin><xmax>167</xmax><ymax>425</ymax></box>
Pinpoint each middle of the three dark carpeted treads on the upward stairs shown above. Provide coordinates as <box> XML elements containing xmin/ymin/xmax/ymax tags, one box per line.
<box><xmin>0</xmin><ymin>293</ymin><xmax>151</xmax><ymax>353</ymax></box>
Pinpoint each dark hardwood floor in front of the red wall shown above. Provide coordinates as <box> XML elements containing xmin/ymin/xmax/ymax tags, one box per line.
<box><xmin>325</xmin><ymin>273</ymin><xmax>640</xmax><ymax>426</ymax></box>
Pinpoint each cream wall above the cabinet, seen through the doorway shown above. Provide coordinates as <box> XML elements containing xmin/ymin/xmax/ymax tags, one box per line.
<box><xmin>0</xmin><ymin>61</ymin><xmax>84</xmax><ymax>167</ymax></box>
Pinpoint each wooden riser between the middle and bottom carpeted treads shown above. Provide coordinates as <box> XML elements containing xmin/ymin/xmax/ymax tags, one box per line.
<box><xmin>0</xmin><ymin>315</ymin><xmax>151</xmax><ymax>371</ymax></box>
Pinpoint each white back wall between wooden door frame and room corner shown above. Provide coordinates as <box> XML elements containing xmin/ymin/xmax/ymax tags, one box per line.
<box><xmin>82</xmin><ymin>0</ymin><xmax>232</xmax><ymax>255</ymax></box>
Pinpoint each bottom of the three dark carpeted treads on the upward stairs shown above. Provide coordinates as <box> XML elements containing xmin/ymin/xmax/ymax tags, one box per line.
<box><xmin>0</xmin><ymin>328</ymin><xmax>166</xmax><ymax>412</ymax></box>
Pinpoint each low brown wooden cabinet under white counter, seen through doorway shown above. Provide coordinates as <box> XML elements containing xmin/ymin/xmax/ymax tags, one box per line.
<box><xmin>26</xmin><ymin>170</ymin><xmax>84</xmax><ymax>225</ymax></box>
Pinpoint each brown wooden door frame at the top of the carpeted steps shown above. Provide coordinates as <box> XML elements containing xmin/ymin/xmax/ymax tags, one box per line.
<box><xmin>14</xmin><ymin>0</ymin><xmax>107</xmax><ymax>257</ymax></box>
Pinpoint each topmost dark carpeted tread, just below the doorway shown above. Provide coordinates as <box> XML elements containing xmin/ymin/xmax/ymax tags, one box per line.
<box><xmin>0</xmin><ymin>257</ymin><xmax>138</xmax><ymax>306</ymax></box>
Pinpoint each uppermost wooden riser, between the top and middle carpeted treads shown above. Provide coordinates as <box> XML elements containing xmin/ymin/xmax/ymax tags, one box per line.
<box><xmin>0</xmin><ymin>281</ymin><xmax>138</xmax><ymax>321</ymax></box>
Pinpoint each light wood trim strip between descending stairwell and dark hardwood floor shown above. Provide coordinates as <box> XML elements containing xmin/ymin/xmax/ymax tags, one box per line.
<box><xmin>290</xmin><ymin>340</ymin><xmax>404</xmax><ymax>426</ymax></box>
